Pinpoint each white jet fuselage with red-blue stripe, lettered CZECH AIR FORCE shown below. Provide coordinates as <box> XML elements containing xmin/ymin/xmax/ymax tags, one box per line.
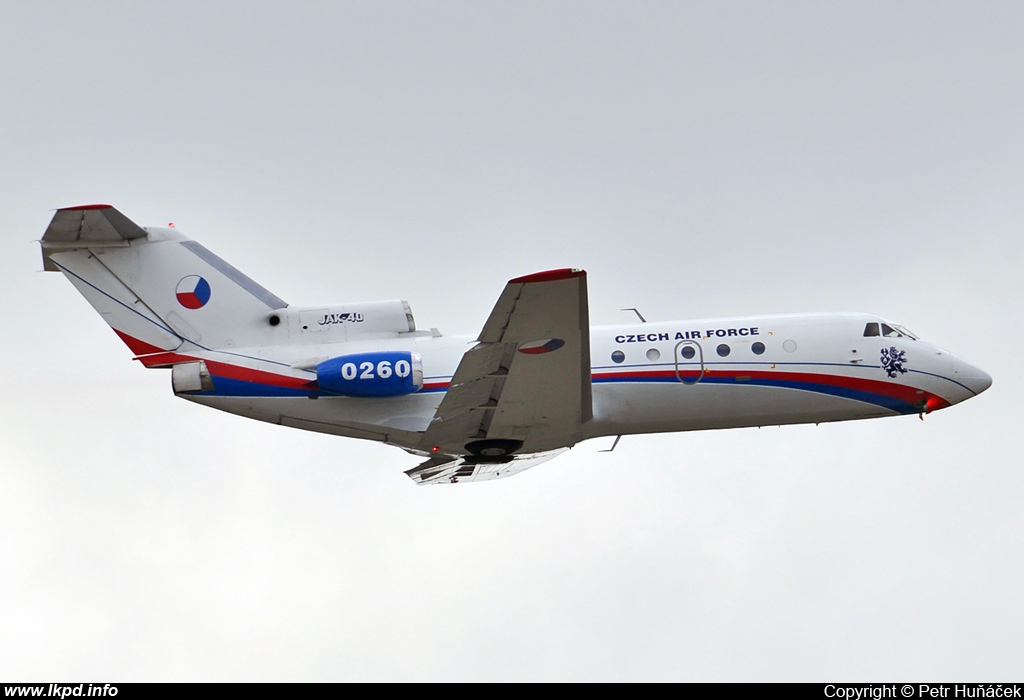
<box><xmin>177</xmin><ymin>313</ymin><xmax>991</xmax><ymax>449</ymax></box>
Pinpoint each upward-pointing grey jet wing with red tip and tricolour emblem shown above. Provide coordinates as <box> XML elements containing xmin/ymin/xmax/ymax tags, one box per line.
<box><xmin>420</xmin><ymin>269</ymin><xmax>592</xmax><ymax>464</ymax></box>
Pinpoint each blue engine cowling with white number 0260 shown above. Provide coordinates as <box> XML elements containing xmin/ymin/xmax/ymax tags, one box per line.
<box><xmin>316</xmin><ymin>352</ymin><xmax>423</xmax><ymax>396</ymax></box>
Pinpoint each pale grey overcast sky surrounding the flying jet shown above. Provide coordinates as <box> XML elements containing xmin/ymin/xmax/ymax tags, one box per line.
<box><xmin>0</xmin><ymin>2</ymin><xmax>1024</xmax><ymax>681</ymax></box>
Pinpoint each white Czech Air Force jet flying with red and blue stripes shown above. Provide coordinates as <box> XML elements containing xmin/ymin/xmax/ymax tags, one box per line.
<box><xmin>40</xmin><ymin>205</ymin><xmax>992</xmax><ymax>484</ymax></box>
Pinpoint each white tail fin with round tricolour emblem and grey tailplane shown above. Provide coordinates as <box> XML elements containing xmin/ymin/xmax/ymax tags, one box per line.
<box><xmin>40</xmin><ymin>205</ymin><xmax>288</xmax><ymax>355</ymax></box>
